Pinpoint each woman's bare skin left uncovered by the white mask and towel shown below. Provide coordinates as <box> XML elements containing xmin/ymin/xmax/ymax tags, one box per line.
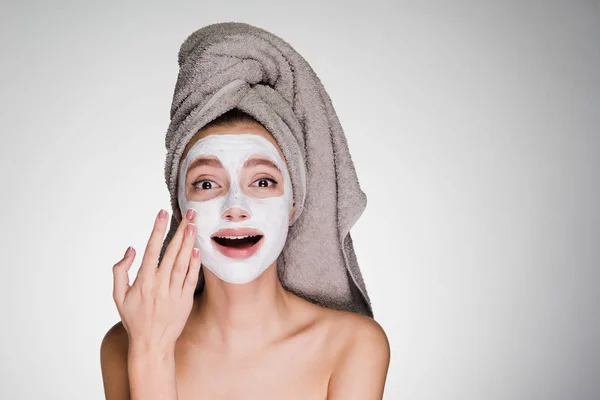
<box><xmin>101</xmin><ymin>124</ymin><xmax>390</xmax><ymax>400</ymax></box>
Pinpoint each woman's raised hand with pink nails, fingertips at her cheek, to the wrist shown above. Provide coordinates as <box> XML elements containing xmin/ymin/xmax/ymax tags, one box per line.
<box><xmin>113</xmin><ymin>209</ymin><xmax>200</xmax><ymax>351</ymax></box>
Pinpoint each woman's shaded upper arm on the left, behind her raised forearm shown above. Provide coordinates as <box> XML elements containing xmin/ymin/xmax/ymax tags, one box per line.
<box><xmin>100</xmin><ymin>321</ymin><xmax>129</xmax><ymax>400</ymax></box>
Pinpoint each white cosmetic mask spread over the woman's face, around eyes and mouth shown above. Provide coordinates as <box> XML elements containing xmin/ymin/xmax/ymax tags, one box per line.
<box><xmin>178</xmin><ymin>133</ymin><xmax>293</xmax><ymax>284</ymax></box>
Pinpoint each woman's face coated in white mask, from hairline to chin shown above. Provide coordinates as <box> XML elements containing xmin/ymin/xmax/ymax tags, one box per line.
<box><xmin>178</xmin><ymin>123</ymin><xmax>294</xmax><ymax>283</ymax></box>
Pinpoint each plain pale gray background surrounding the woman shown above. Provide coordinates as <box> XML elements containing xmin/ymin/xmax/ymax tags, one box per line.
<box><xmin>0</xmin><ymin>0</ymin><xmax>600</xmax><ymax>400</ymax></box>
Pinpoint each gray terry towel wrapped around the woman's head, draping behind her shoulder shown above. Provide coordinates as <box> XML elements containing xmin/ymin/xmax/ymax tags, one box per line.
<box><xmin>159</xmin><ymin>22</ymin><xmax>373</xmax><ymax>317</ymax></box>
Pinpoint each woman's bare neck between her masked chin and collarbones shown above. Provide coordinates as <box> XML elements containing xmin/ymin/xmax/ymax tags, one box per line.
<box><xmin>193</xmin><ymin>263</ymin><xmax>292</xmax><ymax>354</ymax></box>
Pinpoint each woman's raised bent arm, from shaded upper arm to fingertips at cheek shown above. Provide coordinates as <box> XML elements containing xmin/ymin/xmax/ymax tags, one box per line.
<box><xmin>101</xmin><ymin>210</ymin><xmax>200</xmax><ymax>400</ymax></box>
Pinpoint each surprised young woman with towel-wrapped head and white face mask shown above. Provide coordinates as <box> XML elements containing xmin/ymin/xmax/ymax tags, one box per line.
<box><xmin>101</xmin><ymin>23</ymin><xmax>390</xmax><ymax>400</ymax></box>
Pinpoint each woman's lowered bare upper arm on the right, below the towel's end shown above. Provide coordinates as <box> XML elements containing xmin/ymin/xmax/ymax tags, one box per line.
<box><xmin>327</xmin><ymin>318</ymin><xmax>390</xmax><ymax>400</ymax></box>
